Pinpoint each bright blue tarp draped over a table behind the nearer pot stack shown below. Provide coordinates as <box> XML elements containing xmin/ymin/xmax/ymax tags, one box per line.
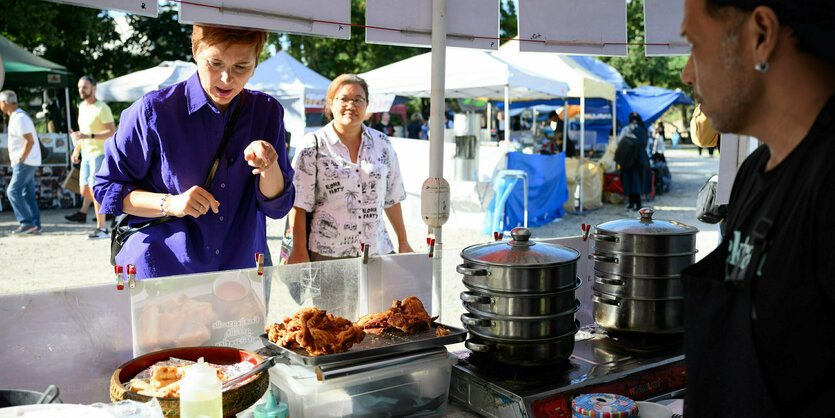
<box><xmin>481</xmin><ymin>152</ymin><xmax>568</xmax><ymax>235</ymax></box>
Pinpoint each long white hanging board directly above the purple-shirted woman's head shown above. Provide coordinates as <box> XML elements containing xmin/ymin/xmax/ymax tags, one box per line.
<box><xmin>180</xmin><ymin>0</ymin><xmax>351</xmax><ymax>39</ymax></box>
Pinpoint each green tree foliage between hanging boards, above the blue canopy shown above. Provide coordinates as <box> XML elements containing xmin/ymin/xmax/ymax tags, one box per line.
<box><xmin>601</xmin><ymin>0</ymin><xmax>687</xmax><ymax>89</ymax></box>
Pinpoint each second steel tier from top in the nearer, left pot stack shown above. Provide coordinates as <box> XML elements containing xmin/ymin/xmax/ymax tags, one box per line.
<box><xmin>461</xmin><ymin>277</ymin><xmax>582</xmax><ymax>317</ymax></box>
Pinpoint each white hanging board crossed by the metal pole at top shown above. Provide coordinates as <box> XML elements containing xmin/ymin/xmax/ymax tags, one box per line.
<box><xmin>365</xmin><ymin>0</ymin><xmax>499</xmax><ymax>50</ymax></box>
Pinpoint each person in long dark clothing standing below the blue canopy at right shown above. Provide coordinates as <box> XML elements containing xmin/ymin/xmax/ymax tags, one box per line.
<box><xmin>618</xmin><ymin>112</ymin><xmax>652</xmax><ymax>210</ymax></box>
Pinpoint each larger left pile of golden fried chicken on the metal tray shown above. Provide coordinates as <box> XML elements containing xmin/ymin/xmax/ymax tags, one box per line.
<box><xmin>266</xmin><ymin>307</ymin><xmax>365</xmax><ymax>356</ymax></box>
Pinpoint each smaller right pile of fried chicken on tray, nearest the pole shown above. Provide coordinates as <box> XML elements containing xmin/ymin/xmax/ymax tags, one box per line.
<box><xmin>357</xmin><ymin>296</ymin><xmax>437</xmax><ymax>335</ymax></box>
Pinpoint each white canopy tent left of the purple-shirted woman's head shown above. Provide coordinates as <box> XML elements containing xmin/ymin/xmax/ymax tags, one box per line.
<box><xmin>96</xmin><ymin>61</ymin><xmax>197</xmax><ymax>102</ymax></box>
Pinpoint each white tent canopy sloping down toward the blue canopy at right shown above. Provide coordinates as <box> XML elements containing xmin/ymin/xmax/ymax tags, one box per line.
<box><xmin>493</xmin><ymin>41</ymin><xmax>615</xmax><ymax>101</ymax></box>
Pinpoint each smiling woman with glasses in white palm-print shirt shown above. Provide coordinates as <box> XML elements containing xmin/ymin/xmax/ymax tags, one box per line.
<box><xmin>287</xmin><ymin>74</ymin><xmax>412</xmax><ymax>264</ymax></box>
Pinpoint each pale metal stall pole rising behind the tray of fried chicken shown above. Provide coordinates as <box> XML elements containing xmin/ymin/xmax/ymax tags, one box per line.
<box><xmin>429</xmin><ymin>0</ymin><xmax>446</xmax><ymax>316</ymax></box>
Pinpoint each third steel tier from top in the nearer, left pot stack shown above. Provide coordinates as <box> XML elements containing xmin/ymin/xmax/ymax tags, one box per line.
<box><xmin>461</xmin><ymin>301</ymin><xmax>580</xmax><ymax>340</ymax></box>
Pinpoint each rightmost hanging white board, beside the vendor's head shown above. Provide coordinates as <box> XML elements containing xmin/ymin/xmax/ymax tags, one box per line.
<box><xmin>644</xmin><ymin>0</ymin><xmax>690</xmax><ymax>57</ymax></box>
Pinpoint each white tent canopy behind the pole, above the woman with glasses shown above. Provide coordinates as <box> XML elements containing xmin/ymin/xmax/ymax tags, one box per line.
<box><xmin>360</xmin><ymin>47</ymin><xmax>568</xmax><ymax>100</ymax></box>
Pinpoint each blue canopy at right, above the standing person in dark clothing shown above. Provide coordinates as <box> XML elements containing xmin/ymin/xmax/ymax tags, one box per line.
<box><xmin>617</xmin><ymin>86</ymin><xmax>693</xmax><ymax>126</ymax></box>
